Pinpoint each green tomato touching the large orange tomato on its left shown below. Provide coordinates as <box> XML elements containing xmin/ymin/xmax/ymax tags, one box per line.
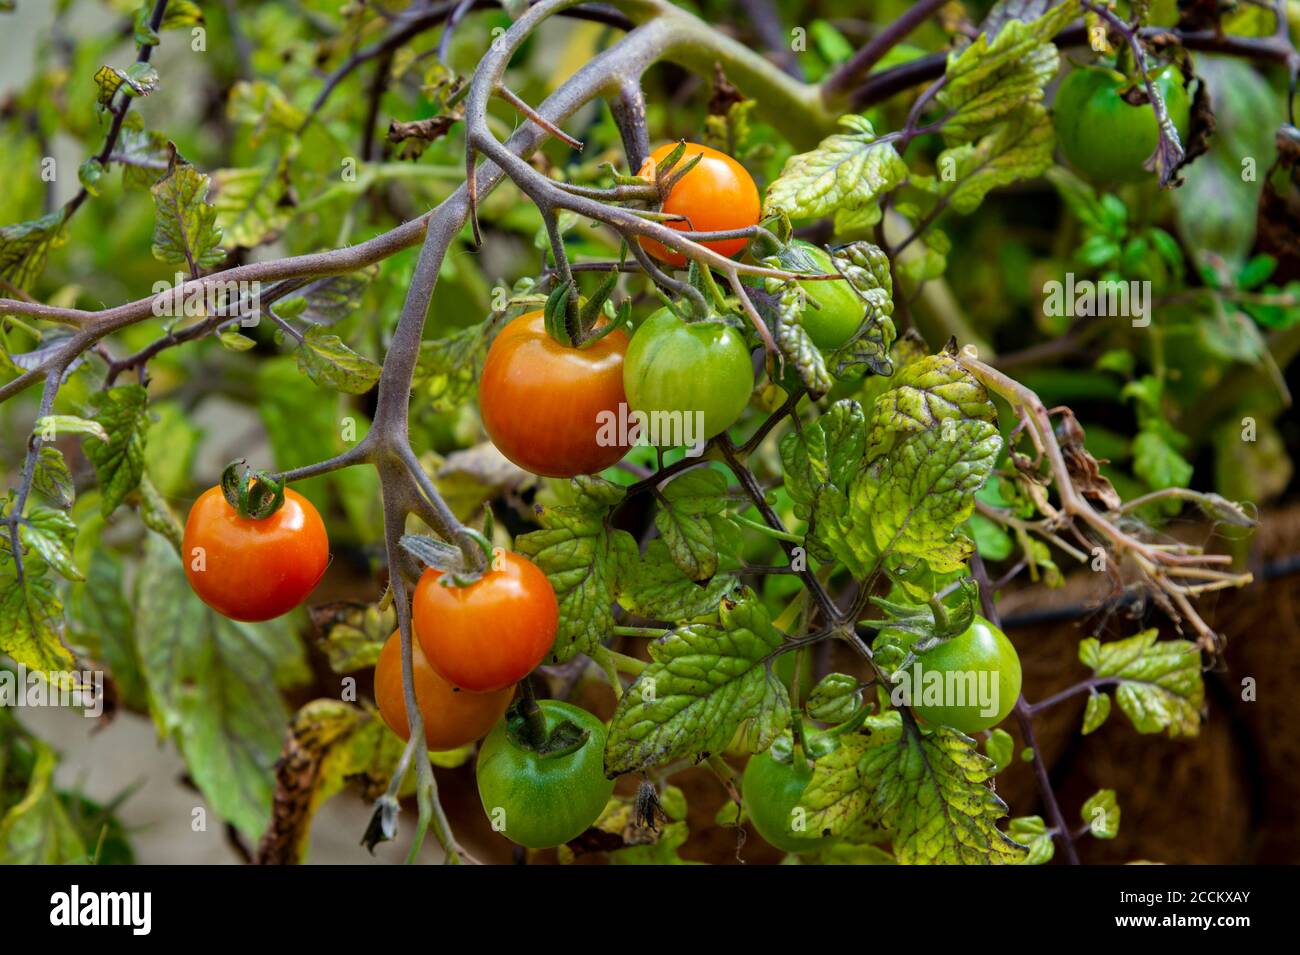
<box><xmin>623</xmin><ymin>308</ymin><xmax>754</xmax><ymax>444</ymax></box>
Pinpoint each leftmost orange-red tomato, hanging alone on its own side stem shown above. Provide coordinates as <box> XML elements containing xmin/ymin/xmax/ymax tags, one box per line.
<box><xmin>181</xmin><ymin>487</ymin><xmax>329</xmax><ymax>621</ymax></box>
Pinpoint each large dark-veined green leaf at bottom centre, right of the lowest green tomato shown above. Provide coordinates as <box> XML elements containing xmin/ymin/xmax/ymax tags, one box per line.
<box><xmin>605</xmin><ymin>591</ymin><xmax>790</xmax><ymax>776</ymax></box>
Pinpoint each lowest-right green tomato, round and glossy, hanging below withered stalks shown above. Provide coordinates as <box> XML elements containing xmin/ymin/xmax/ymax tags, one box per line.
<box><xmin>907</xmin><ymin>616</ymin><xmax>1021</xmax><ymax>733</ymax></box>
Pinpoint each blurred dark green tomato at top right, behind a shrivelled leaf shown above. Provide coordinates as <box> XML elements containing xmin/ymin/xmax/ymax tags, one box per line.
<box><xmin>1052</xmin><ymin>66</ymin><xmax>1191</xmax><ymax>182</ymax></box>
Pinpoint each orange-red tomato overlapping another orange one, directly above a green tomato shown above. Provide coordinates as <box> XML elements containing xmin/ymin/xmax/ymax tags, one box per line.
<box><xmin>412</xmin><ymin>551</ymin><xmax>559</xmax><ymax>693</ymax></box>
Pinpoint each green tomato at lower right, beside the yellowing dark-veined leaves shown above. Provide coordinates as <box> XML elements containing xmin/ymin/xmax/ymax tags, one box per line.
<box><xmin>881</xmin><ymin>616</ymin><xmax>1021</xmax><ymax>733</ymax></box>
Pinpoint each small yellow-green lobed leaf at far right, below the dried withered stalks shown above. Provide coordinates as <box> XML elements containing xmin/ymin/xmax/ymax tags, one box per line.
<box><xmin>1079</xmin><ymin>629</ymin><xmax>1205</xmax><ymax>738</ymax></box>
